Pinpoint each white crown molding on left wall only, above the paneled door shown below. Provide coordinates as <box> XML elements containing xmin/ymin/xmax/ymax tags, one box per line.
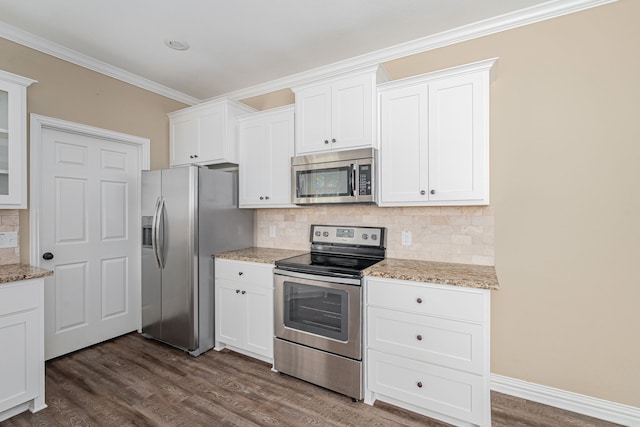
<box><xmin>0</xmin><ymin>21</ymin><xmax>202</xmax><ymax>105</ymax></box>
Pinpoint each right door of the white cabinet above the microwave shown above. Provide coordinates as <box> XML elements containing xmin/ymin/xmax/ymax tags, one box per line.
<box><xmin>329</xmin><ymin>74</ymin><xmax>375</xmax><ymax>150</ymax></box>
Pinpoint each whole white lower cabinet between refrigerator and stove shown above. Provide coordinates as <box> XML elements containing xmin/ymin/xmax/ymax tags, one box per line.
<box><xmin>215</xmin><ymin>259</ymin><xmax>273</xmax><ymax>363</ymax></box>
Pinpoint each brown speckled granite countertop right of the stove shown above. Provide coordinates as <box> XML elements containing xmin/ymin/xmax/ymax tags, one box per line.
<box><xmin>364</xmin><ymin>258</ymin><xmax>499</xmax><ymax>290</ymax></box>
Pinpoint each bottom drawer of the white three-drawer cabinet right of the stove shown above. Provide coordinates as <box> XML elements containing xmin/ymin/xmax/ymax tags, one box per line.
<box><xmin>367</xmin><ymin>350</ymin><xmax>489</xmax><ymax>424</ymax></box>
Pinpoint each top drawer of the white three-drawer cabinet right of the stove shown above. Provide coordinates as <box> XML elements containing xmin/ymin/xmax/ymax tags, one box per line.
<box><xmin>366</xmin><ymin>278</ymin><xmax>489</xmax><ymax>322</ymax></box>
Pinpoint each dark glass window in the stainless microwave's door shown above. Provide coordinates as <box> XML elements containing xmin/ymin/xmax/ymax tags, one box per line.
<box><xmin>297</xmin><ymin>166</ymin><xmax>351</xmax><ymax>198</ymax></box>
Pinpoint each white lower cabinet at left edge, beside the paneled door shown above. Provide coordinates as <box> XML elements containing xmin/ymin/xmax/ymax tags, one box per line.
<box><xmin>0</xmin><ymin>279</ymin><xmax>47</xmax><ymax>421</ymax></box>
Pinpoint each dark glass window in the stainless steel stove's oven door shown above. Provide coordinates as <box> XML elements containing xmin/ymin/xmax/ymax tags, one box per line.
<box><xmin>284</xmin><ymin>282</ymin><xmax>349</xmax><ymax>341</ymax></box>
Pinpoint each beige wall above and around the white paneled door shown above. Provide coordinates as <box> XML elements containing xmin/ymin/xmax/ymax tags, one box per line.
<box><xmin>0</xmin><ymin>38</ymin><xmax>186</xmax><ymax>263</ymax></box>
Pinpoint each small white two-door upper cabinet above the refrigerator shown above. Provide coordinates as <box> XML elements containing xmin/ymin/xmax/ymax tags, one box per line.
<box><xmin>169</xmin><ymin>99</ymin><xmax>255</xmax><ymax>167</ymax></box>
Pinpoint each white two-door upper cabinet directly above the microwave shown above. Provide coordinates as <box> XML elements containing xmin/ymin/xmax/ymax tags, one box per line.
<box><xmin>293</xmin><ymin>66</ymin><xmax>388</xmax><ymax>155</ymax></box>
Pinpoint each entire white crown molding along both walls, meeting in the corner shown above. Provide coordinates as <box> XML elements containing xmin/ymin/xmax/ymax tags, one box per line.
<box><xmin>0</xmin><ymin>0</ymin><xmax>618</xmax><ymax>105</ymax></box>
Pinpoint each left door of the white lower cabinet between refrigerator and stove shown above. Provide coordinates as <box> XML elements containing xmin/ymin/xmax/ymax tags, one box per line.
<box><xmin>215</xmin><ymin>278</ymin><xmax>244</xmax><ymax>347</ymax></box>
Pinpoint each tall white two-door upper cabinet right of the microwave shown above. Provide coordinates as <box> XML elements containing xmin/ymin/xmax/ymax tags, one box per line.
<box><xmin>378</xmin><ymin>59</ymin><xmax>495</xmax><ymax>206</ymax></box>
